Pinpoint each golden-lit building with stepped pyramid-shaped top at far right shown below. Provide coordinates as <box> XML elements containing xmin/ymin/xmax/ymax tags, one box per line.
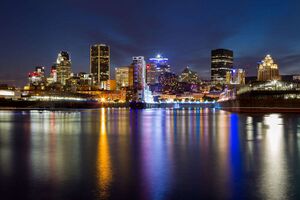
<box><xmin>257</xmin><ymin>55</ymin><xmax>281</xmax><ymax>81</ymax></box>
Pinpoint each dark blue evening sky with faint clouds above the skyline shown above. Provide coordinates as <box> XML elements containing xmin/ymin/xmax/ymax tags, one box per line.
<box><xmin>0</xmin><ymin>0</ymin><xmax>300</xmax><ymax>85</ymax></box>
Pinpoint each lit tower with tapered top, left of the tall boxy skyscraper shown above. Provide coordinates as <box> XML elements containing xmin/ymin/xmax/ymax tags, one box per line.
<box><xmin>56</xmin><ymin>51</ymin><xmax>72</xmax><ymax>85</ymax></box>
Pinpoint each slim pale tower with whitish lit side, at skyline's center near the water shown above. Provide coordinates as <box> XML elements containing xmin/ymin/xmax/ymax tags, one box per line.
<box><xmin>132</xmin><ymin>56</ymin><xmax>146</xmax><ymax>90</ymax></box>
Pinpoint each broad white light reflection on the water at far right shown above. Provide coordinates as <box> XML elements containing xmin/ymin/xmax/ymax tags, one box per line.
<box><xmin>261</xmin><ymin>114</ymin><xmax>289</xmax><ymax>199</ymax></box>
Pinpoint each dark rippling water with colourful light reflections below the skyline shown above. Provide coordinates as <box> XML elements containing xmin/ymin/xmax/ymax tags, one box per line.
<box><xmin>0</xmin><ymin>109</ymin><xmax>300</xmax><ymax>200</ymax></box>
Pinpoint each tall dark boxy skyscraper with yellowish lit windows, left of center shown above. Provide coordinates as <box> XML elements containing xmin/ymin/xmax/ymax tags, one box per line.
<box><xmin>90</xmin><ymin>44</ymin><xmax>110</xmax><ymax>89</ymax></box>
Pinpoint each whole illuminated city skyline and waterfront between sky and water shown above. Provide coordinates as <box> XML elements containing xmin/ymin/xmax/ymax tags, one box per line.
<box><xmin>0</xmin><ymin>44</ymin><xmax>300</xmax><ymax>111</ymax></box>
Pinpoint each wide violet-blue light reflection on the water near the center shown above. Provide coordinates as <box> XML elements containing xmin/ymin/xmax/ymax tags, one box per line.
<box><xmin>141</xmin><ymin>110</ymin><xmax>172</xmax><ymax>199</ymax></box>
